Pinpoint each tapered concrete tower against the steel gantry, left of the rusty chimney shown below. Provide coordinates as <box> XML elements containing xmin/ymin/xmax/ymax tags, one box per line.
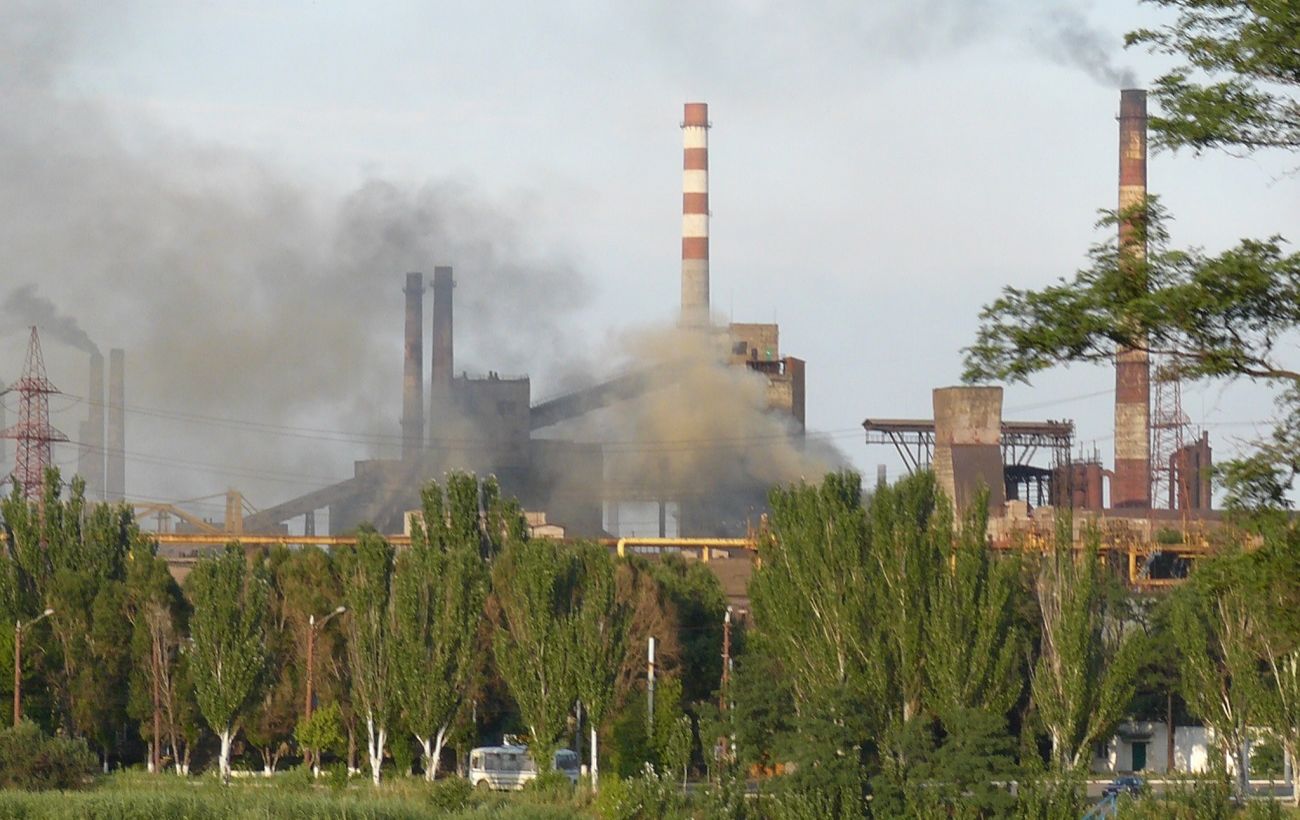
<box><xmin>933</xmin><ymin>387</ymin><xmax>1006</xmax><ymax>513</ymax></box>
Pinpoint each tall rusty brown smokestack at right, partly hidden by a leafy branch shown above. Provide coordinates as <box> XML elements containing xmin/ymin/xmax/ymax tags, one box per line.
<box><xmin>1110</xmin><ymin>88</ymin><xmax>1152</xmax><ymax>508</ymax></box>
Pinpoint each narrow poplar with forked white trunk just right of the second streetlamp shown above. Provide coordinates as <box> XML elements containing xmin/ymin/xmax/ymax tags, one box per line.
<box><xmin>339</xmin><ymin>529</ymin><xmax>397</xmax><ymax>785</ymax></box>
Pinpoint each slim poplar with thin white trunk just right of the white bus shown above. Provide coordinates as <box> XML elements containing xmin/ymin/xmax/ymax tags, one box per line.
<box><xmin>573</xmin><ymin>545</ymin><xmax>629</xmax><ymax>791</ymax></box>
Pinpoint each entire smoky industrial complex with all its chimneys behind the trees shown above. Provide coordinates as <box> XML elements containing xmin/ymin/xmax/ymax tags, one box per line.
<box><xmin>5</xmin><ymin>90</ymin><xmax>1217</xmax><ymax>583</ymax></box>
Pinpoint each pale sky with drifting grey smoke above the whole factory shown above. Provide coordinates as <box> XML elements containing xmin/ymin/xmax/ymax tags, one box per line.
<box><xmin>0</xmin><ymin>0</ymin><xmax>1300</xmax><ymax>515</ymax></box>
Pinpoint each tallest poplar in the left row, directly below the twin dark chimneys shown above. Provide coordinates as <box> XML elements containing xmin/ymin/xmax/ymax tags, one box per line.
<box><xmin>393</xmin><ymin>473</ymin><xmax>488</xmax><ymax>781</ymax></box>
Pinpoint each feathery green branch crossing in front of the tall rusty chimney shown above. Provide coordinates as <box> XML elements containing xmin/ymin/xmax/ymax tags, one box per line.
<box><xmin>965</xmin><ymin>202</ymin><xmax>1300</xmax><ymax>509</ymax></box>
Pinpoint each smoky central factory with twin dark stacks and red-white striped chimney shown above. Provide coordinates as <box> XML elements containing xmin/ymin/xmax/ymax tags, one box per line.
<box><xmin>230</xmin><ymin>103</ymin><xmax>806</xmax><ymax>537</ymax></box>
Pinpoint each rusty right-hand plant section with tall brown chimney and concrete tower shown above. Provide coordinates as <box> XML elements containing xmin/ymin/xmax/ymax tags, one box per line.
<box><xmin>863</xmin><ymin>88</ymin><xmax>1218</xmax><ymax>583</ymax></box>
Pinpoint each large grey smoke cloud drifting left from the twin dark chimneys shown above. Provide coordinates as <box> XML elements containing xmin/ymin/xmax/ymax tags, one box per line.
<box><xmin>0</xmin><ymin>0</ymin><xmax>588</xmax><ymax>506</ymax></box>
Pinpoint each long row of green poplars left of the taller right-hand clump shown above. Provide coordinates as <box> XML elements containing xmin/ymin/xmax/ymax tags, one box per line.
<box><xmin>0</xmin><ymin>470</ymin><xmax>727</xmax><ymax>782</ymax></box>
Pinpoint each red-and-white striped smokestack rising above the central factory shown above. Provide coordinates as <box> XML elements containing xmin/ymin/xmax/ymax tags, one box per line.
<box><xmin>681</xmin><ymin>103</ymin><xmax>709</xmax><ymax>327</ymax></box>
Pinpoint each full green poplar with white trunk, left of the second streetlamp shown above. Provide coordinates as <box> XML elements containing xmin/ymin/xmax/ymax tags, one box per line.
<box><xmin>186</xmin><ymin>543</ymin><xmax>268</xmax><ymax>782</ymax></box>
